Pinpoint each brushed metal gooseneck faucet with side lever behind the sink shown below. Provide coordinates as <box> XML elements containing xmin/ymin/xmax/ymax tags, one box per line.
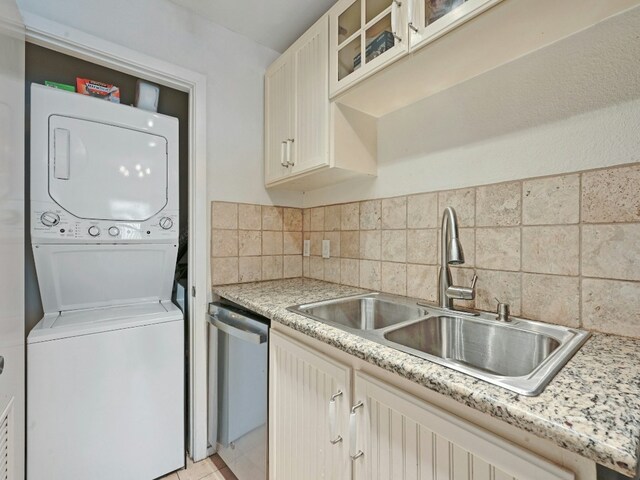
<box><xmin>438</xmin><ymin>207</ymin><xmax>478</xmax><ymax>310</ymax></box>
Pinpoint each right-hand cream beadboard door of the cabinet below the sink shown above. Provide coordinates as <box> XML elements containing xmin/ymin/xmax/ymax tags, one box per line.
<box><xmin>353</xmin><ymin>372</ymin><xmax>574</xmax><ymax>480</ymax></box>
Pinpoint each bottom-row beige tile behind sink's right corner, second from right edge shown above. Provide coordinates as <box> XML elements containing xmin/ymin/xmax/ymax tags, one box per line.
<box><xmin>522</xmin><ymin>273</ymin><xmax>580</xmax><ymax>328</ymax></box>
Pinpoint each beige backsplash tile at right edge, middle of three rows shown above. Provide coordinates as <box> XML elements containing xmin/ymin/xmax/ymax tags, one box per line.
<box><xmin>582</xmin><ymin>224</ymin><xmax>640</xmax><ymax>280</ymax></box>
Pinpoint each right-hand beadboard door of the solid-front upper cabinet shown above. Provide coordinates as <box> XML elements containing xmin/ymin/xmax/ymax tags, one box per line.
<box><xmin>291</xmin><ymin>16</ymin><xmax>329</xmax><ymax>174</ymax></box>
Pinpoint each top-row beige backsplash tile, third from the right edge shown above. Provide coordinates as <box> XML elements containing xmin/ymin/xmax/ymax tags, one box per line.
<box><xmin>476</xmin><ymin>182</ymin><xmax>522</xmax><ymax>227</ymax></box>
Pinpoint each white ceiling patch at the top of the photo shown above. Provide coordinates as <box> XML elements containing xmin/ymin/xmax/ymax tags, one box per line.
<box><xmin>171</xmin><ymin>0</ymin><xmax>335</xmax><ymax>52</ymax></box>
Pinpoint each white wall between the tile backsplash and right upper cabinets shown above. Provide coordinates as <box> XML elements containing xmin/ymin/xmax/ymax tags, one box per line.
<box><xmin>304</xmin><ymin>9</ymin><xmax>640</xmax><ymax>207</ymax></box>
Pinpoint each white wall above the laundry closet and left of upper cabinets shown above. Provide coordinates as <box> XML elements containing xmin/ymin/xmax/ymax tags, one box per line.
<box><xmin>18</xmin><ymin>0</ymin><xmax>301</xmax><ymax>206</ymax></box>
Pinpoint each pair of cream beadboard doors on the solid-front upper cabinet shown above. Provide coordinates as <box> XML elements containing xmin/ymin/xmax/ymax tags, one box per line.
<box><xmin>265</xmin><ymin>17</ymin><xmax>329</xmax><ymax>186</ymax></box>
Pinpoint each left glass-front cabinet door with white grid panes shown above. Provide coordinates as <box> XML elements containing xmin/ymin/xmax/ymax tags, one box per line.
<box><xmin>329</xmin><ymin>0</ymin><xmax>409</xmax><ymax>96</ymax></box>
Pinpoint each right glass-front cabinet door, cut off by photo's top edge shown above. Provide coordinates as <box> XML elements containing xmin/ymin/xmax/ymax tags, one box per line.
<box><xmin>407</xmin><ymin>0</ymin><xmax>501</xmax><ymax>50</ymax></box>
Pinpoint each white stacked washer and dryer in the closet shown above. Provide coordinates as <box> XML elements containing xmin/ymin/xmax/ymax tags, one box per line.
<box><xmin>27</xmin><ymin>85</ymin><xmax>184</xmax><ymax>480</ymax></box>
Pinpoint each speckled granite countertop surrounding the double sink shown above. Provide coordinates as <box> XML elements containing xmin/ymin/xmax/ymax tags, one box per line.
<box><xmin>213</xmin><ymin>278</ymin><xmax>640</xmax><ymax>477</ymax></box>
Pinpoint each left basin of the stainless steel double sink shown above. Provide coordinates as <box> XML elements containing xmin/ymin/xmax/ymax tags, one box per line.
<box><xmin>289</xmin><ymin>293</ymin><xmax>427</xmax><ymax>330</ymax></box>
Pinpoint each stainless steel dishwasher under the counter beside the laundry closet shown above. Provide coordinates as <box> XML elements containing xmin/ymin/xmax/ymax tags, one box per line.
<box><xmin>209</xmin><ymin>299</ymin><xmax>269</xmax><ymax>480</ymax></box>
